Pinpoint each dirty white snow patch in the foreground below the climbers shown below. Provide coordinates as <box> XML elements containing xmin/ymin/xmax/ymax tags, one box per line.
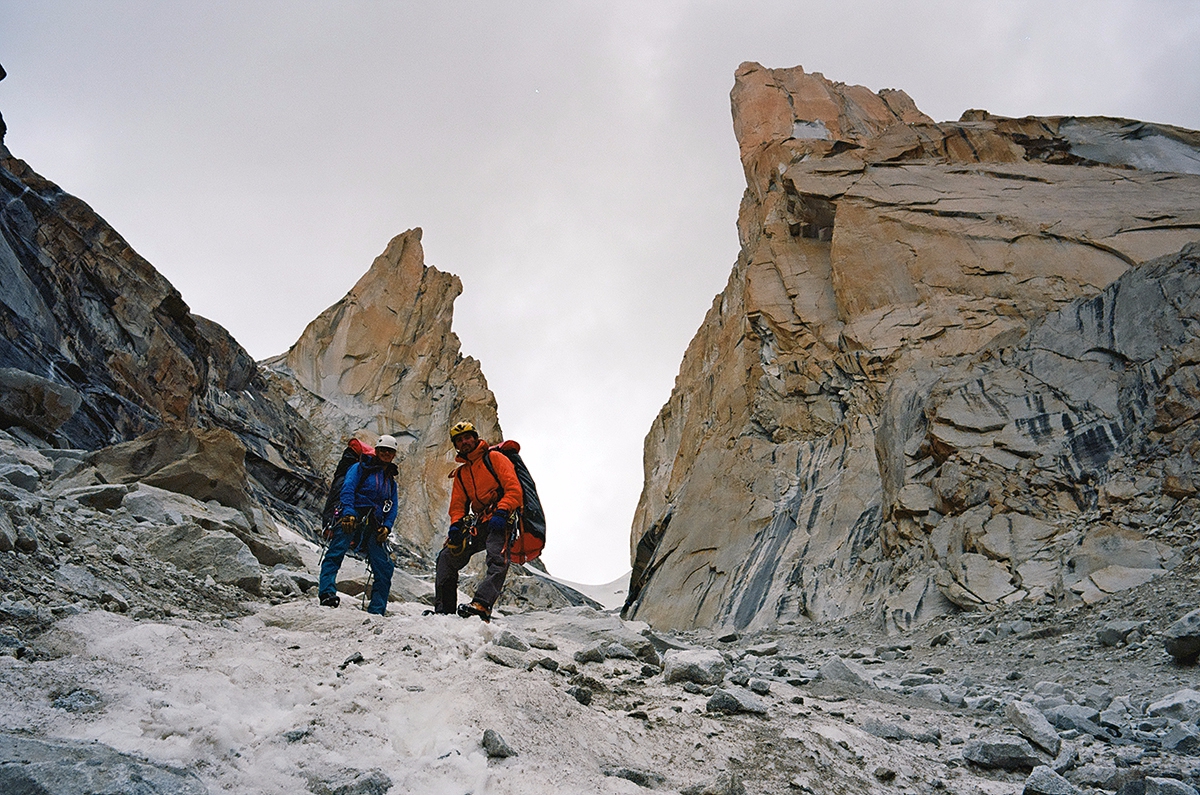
<box><xmin>0</xmin><ymin>602</ymin><xmax>719</xmax><ymax>795</ymax></box>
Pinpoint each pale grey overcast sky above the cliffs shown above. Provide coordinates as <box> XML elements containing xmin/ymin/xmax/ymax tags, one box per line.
<box><xmin>0</xmin><ymin>0</ymin><xmax>1200</xmax><ymax>582</ymax></box>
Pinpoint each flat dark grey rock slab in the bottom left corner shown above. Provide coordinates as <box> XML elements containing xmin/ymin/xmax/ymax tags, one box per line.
<box><xmin>0</xmin><ymin>734</ymin><xmax>209</xmax><ymax>795</ymax></box>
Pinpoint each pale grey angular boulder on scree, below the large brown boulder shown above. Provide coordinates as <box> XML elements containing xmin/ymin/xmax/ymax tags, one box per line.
<box><xmin>140</xmin><ymin>521</ymin><xmax>263</xmax><ymax>594</ymax></box>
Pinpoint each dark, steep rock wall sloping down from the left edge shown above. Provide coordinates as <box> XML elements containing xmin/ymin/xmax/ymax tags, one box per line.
<box><xmin>0</xmin><ymin>147</ymin><xmax>322</xmax><ymax>518</ymax></box>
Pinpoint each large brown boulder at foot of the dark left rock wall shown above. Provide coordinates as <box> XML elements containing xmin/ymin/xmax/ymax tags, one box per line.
<box><xmin>89</xmin><ymin>429</ymin><xmax>252</xmax><ymax>512</ymax></box>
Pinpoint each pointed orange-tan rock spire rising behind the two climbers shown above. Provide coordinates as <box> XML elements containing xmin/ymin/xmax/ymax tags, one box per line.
<box><xmin>266</xmin><ymin>229</ymin><xmax>500</xmax><ymax>548</ymax></box>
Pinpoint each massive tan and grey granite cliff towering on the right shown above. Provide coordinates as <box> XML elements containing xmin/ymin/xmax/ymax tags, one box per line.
<box><xmin>626</xmin><ymin>64</ymin><xmax>1200</xmax><ymax>628</ymax></box>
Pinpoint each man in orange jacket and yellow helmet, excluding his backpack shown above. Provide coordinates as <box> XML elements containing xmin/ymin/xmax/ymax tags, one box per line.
<box><xmin>433</xmin><ymin>423</ymin><xmax>523</xmax><ymax>621</ymax></box>
